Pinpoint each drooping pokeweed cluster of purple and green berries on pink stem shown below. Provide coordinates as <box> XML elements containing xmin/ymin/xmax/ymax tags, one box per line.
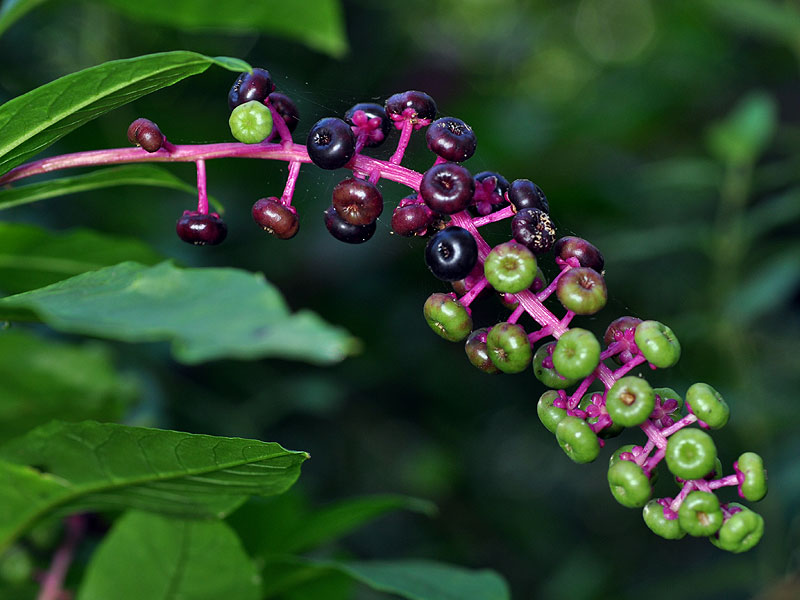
<box><xmin>7</xmin><ymin>64</ymin><xmax>767</xmax><ymax>552</ymax></box>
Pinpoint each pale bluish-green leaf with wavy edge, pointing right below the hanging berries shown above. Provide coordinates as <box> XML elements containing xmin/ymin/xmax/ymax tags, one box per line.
<box><xmin>0</xmin><ymin>262</ymin><xmax>356</xmax><ymax>364</ymax></box>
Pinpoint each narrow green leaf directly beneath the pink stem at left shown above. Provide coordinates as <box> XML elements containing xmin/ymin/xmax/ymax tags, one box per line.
<box><xmin>0</xmin><ymin>165</ymin><xmax>223</xmax><ymax>213</ymax></box>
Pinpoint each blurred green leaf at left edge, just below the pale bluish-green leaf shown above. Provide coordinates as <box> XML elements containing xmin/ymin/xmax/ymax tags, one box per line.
<box><xmin>0</xmin><ymin>329</ymin><xmax>138</xmax><ymax>440</ymax></box>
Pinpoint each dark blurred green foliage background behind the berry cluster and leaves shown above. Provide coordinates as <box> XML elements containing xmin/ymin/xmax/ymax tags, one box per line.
<box><xmin>0</xmin><ymin>0</ymin><xmax>800</xmax><ymax>600</ymax></box>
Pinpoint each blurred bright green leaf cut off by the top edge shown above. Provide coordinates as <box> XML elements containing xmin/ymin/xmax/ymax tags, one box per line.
<box><xmin>97</xmin><ymin>0</ymin><xmax>347</xmax><ymax>57</ymax></box>
